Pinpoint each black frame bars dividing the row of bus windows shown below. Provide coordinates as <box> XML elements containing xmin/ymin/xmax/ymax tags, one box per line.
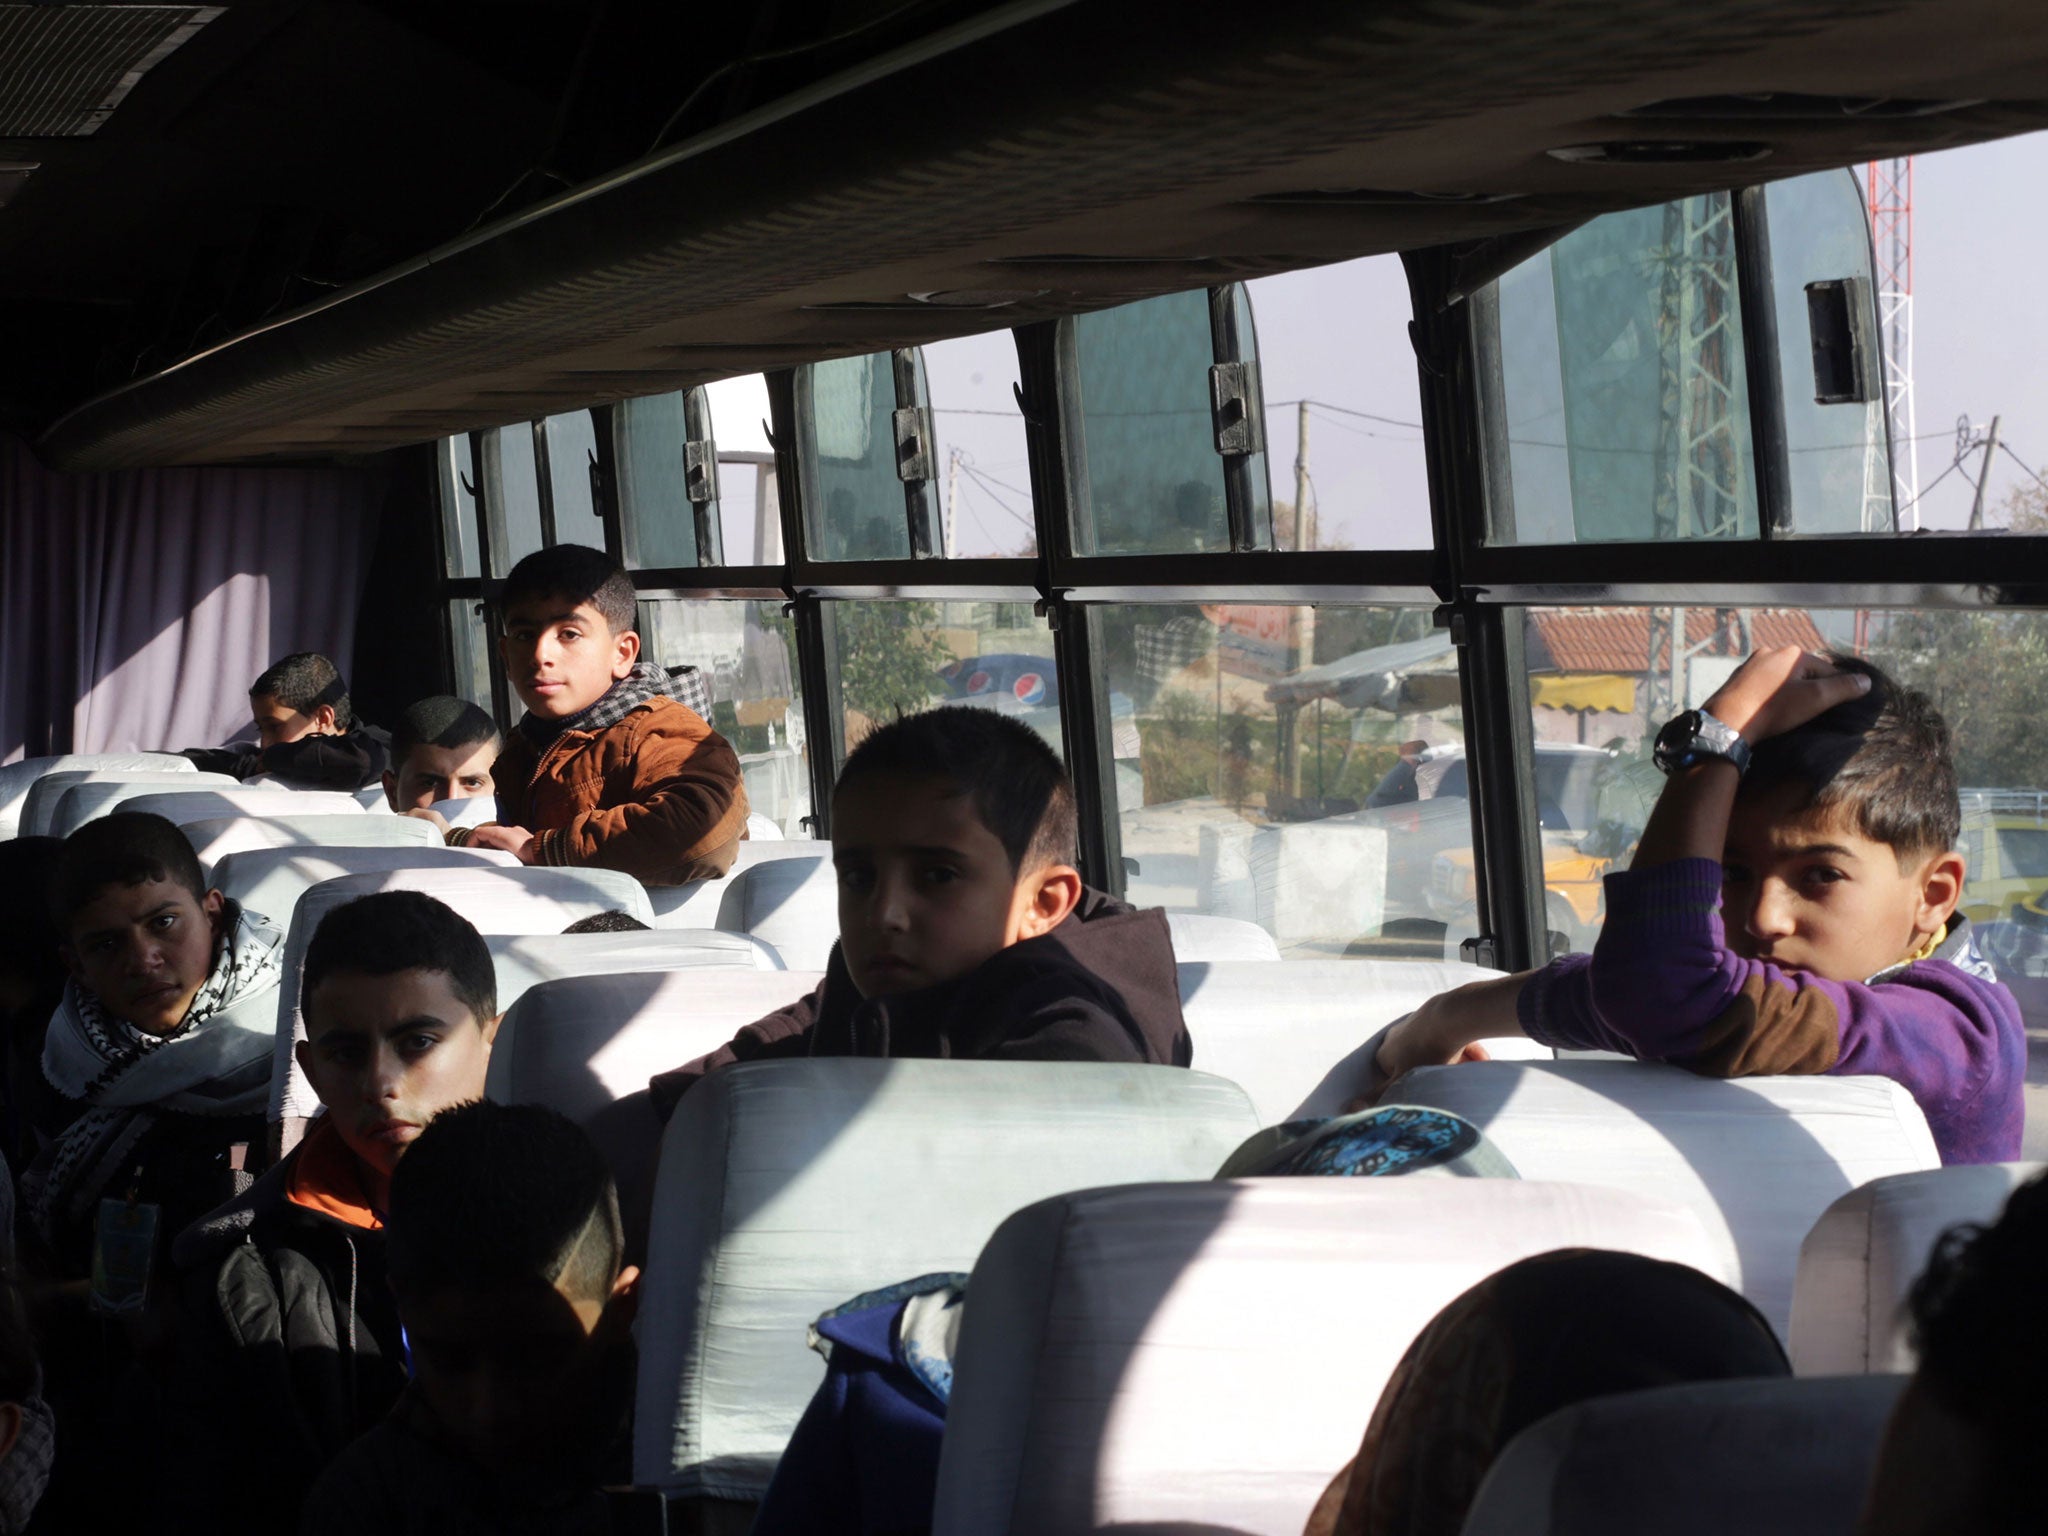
<box><xmin>415</xmin><ymin>186</ymin><xmax>2048</xmax><ymax>969</ymax></box>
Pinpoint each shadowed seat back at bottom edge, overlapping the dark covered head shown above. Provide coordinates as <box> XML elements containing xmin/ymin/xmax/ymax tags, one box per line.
<box><xmin>1464</xmin><ymin>1376</ymin><xmax>1905</xmax><ymax>1536</ymax></box>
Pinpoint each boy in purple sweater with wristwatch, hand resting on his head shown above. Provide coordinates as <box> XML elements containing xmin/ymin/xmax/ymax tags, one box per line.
<box><xmin>1374</xmin><ymin>647</ymin><xmax>2028</xmax><ymax>1163</ymax></box>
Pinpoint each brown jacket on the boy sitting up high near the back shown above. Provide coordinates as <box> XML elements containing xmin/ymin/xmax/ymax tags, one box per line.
<box><xmin>481</xmin><ymin>698</ymin><xmax>748</xmax><ymax>885</ymax></box>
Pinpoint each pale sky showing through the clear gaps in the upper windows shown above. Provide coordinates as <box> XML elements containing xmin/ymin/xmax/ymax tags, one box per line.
<box><xmin>713</xmin><ymin>133</ymin><xmax>2048</xmax><ymax>559</ymax></box>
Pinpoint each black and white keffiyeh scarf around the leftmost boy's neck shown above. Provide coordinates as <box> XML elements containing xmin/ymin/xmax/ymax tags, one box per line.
<box><xmin>23</xmin><ymin>903</ymin><xmax>285</xmax><ymax>1237</ymax></box>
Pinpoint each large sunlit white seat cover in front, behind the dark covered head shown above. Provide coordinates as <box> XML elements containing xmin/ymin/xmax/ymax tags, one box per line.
<box><xmin>932</xmin><ymin>1178</ymin><xmax>1720</xmax><ymax>1536</ymax></box>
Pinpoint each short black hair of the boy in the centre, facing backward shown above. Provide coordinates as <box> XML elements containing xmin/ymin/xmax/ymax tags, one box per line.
<box><xmin>834</xmin><ymin>705</ymin><xmax>1079</xmax><ymax>877</ymax></box>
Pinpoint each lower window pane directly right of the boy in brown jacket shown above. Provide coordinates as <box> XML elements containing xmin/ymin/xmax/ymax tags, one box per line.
<box><xmin>641</xmin><ymin>598</ymin><xmax>811</xmax><ymax>838</ymax></box>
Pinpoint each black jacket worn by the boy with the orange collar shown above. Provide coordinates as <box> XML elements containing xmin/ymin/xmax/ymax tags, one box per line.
<box><xmin>170</xmin><ymin>1130</ymin><xmax>406</xmax><ymax>1532</ymax></box>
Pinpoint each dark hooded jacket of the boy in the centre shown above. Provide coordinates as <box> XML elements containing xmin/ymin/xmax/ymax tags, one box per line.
<box><xmin>649</xmin><ymin>891</ymin><xmax>1194</xmax><ymax>1120</ymax></box>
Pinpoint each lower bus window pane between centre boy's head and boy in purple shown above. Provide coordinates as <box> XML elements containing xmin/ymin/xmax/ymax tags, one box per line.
<box><xmin>1092</xmin><ymin>604</ymin><xmax>1473</xmax><ymax>958</ymax></box>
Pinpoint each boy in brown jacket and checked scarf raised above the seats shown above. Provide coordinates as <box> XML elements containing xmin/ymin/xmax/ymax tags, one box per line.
<box><xmin>449</xmin><ymin>545</ymin><xmax>748</xmax><ymax>885</ymax></box>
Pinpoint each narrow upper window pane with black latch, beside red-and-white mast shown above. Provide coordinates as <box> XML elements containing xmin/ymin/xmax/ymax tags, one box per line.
<box><xmin>1763</xmin><ymin>170</ymin><xmax>1892</xmax><ymax>532</ymax></box>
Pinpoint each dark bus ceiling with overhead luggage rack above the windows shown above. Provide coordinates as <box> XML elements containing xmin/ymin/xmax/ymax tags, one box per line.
<box><xmin>12</xmin><ymin>0</ymin><xmax>2048</xmax><ymax>469</ymax></box>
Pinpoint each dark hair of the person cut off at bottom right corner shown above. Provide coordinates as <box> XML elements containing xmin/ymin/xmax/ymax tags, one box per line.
<box><xmin>1907</xmin><ymin>1176</ymin><xmax>2048</xmax><ymax>1536</ymax></box>
